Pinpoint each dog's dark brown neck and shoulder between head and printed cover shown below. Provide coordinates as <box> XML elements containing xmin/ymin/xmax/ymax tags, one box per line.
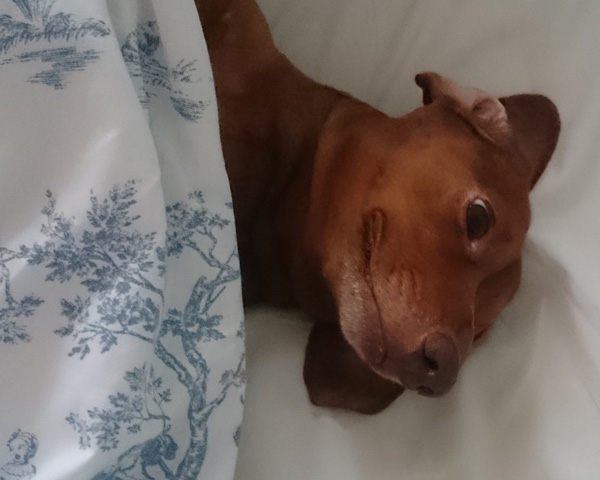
<box><xmin>200</xmin><ymin>1</ymin><xmax>355</xmax><ymax>304</ymax></box>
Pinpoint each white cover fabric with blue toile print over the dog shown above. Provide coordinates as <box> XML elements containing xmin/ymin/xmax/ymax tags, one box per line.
<box><xmin>0</xmin><ymin>0</ymin><xmax>245</xmax><ymax>480</ymax></box>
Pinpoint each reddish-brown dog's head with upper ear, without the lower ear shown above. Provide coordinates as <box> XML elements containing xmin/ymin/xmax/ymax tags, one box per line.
<box><xmin>305</xmin><ymin>73</ymin><xmax>560</xmax><ymax>402</ymax></box>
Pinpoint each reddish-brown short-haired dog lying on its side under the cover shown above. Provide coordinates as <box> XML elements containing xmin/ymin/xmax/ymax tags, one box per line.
<box><xmin>196</xmin><ymin>0</ymin><xmax>559</xmax><ymax>413</ymax></box>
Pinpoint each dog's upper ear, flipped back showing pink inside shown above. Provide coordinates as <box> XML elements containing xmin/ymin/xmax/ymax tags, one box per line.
<box><xmin>415</xmin><ymin>72</ymin><xmax>560</xmax><ymax>188</ymax></box>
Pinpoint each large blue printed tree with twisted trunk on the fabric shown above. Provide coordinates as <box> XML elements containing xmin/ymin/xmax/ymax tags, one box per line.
<box><xmin>20</xmin><ymin>181</ymin><xmax>244</xmax><ymax>480</ymax></box>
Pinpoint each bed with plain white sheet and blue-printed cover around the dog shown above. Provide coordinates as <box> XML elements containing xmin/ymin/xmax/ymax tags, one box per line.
<box><xmin>0</xmin><ymin>0</ymin><xmax>600</xmax><ymax>480</ymax></box>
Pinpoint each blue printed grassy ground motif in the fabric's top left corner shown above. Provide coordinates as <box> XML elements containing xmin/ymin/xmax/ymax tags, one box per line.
<box><xmin>0</xmin><ymin>0</ymin><xmax>110</xmax><ymax>90</ymax></box>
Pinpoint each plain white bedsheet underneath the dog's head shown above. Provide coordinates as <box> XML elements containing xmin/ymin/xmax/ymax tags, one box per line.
<box><xmin>236</xmin><ymin>0</ymin><xmax>600</xmax><ymax>480</ymax></box>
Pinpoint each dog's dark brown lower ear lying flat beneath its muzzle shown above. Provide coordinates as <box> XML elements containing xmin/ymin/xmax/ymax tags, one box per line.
<box><xmin>304</xmin><ymin>322</ymin><xmax>404</xmax><ymax>414</ymax></box>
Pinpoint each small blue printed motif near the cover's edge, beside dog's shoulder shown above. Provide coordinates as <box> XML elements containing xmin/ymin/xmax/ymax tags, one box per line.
<box><xmin>121</xmin><ymin>22</ymin><xmax>206</xmax><ymax>122</ymax></box>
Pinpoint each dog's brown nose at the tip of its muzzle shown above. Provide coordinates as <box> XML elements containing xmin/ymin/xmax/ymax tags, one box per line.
<box><xmin>417</xmin><ymin>332</ymin><xmax>460</xmax><ymax>396</ymax></box>
